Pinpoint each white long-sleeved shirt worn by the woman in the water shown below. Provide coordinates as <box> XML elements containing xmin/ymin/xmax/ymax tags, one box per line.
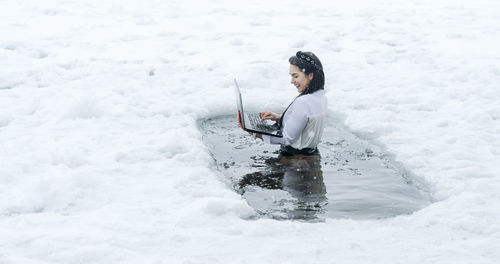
<box><xmin>262</xmin><ymin>90</ymin><xmax>327</xmax><ymax>149</ymax></box>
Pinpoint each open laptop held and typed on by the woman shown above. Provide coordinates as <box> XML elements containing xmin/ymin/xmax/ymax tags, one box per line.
<box><xmin>234</xmin><ymin>79</ymin><xmax>283</xmax><ymax>137</ymax></box>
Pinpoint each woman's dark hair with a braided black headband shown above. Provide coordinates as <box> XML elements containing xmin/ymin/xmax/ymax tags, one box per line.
<box><xmin>288</xmin><ymin>51</ymin><xmax>325</xmax><ymax>95</ymax></box>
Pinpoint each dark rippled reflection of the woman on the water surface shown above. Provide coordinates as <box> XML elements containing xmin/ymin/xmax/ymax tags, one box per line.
<box><xmin>238</xmin><ymin>155</ymin><xmax>328</xmax><ymax>220</ymax></box>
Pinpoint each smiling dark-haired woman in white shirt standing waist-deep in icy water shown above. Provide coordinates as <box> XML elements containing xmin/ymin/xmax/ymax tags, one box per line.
<box><xmin>238</xmin><ymin>51</ymin><xmax>327</xmax><ymax>156</ymax></box>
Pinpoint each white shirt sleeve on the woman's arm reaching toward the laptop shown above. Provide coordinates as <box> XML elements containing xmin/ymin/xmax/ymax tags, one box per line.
<box><xmin>262</xmin><ymin>101</ymin><xmax>309</xmax><ymax>145</ymax></box>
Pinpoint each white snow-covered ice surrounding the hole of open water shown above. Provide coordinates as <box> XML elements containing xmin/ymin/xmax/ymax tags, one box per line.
<box><xmin>0</xmin><ymin>0</ymin><xmax>500</xmax><ymax>264</ymax></box>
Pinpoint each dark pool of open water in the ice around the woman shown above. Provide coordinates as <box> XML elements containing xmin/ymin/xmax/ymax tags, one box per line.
<box><xmin>200</xmin><ymin>115</ymin><xmax>430</xmax><ymax>221</ymax></box>
